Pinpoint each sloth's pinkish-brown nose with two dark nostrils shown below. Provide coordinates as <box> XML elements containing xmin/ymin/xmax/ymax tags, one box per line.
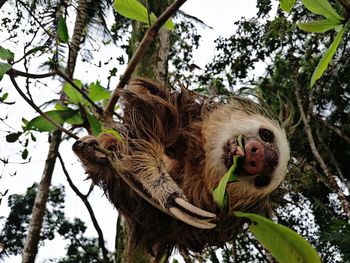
<box><xmin>243</xmin><ymin>139</ymin><xmax>265</xmax><ymax>174</ymax></box>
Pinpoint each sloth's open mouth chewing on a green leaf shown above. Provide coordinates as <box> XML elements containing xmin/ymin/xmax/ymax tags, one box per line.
<box><xmin>223</xmin><ymin>135</ymin><xmax>245</xmax><ymax>169</ymax></box>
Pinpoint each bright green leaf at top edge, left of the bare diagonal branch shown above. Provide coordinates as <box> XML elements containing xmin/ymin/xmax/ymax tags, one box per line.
<box><xmin>113</xmin><ymin>0</ymin><xmax>157</xmax><ymax>24</ymax></box>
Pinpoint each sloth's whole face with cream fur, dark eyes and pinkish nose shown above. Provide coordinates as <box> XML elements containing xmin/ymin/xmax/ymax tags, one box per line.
<box><xmin>202</xmin><ymin>100</ymin><xmax>289</xmax><ymax>204</ymax></box>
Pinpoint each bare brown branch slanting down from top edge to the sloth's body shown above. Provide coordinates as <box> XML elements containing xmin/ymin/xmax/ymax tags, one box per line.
<box><xmin>104</xmin><ymin>0</ymin><xmax>186</xmax><ymax>118</ymax></box>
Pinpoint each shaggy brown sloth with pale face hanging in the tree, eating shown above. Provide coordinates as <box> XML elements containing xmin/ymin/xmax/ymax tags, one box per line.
<box><xmin>73</xmin><ymin>78</ymin><xmax>289</xmax><ymax>258</ymax></box>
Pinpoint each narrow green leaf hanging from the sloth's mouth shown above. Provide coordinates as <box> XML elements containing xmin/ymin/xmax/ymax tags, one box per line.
<box><xmin>213</xmin><ymin>155</ymin><xmax>239</xmax><ymax>209</ymax></box>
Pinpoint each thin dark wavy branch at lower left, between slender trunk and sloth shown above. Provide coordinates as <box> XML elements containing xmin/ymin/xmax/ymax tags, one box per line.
<box><xmin>58</xmin><ymin>153</ymin><xmax>109</xmax><ymax>262</ymax></box>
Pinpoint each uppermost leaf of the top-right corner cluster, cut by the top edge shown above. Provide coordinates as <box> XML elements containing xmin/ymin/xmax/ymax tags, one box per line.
<box><xmin>302</xmin><ymin>0</ymin><xmax>344</xmax><ymax>20</ymax></box>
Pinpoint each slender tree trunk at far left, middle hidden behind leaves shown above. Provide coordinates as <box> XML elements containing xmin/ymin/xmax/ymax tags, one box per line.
<box><xmin>22</xmin><ymin>0</ymin><xmax>87</xmax><ymax>263</ymax></box>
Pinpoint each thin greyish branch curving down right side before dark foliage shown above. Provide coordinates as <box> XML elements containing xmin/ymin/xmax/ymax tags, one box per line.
<box><xmin>295</xmin><ymin>87</ymin><xmax>350</xmax><ymax>218</ymax></box>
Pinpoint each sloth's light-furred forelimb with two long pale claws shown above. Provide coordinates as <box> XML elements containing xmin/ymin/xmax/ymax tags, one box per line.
<box><xmin>131</xmin><ymin>144</ymin><xmax>216</xmax><ymax>229</ymax></box>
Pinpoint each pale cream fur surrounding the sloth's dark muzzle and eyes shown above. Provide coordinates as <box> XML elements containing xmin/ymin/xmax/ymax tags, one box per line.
<box><xmin>202</xmin><ymin>104</ymin><xmax>289</xmax><ymax>198</ymax></box>
